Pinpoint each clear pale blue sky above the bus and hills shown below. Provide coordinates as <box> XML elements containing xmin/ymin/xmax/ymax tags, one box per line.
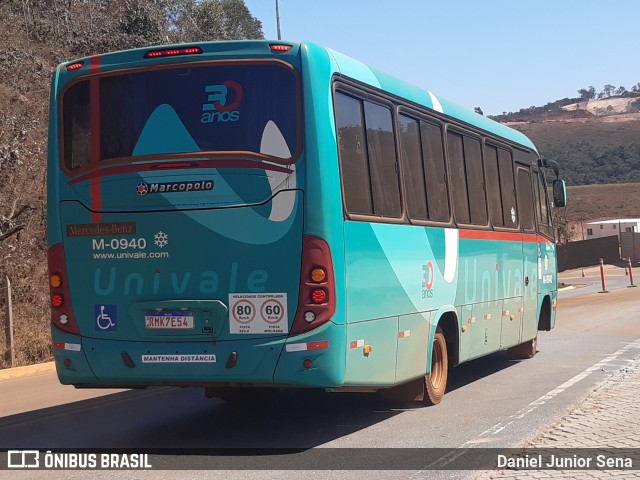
<box><xmin>245</xmin><ymin>0</ymin><xmax>640</xmax><ymax>115</ymax></box>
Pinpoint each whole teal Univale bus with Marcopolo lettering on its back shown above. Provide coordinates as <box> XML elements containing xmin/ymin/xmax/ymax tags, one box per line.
<box><xmin>48</xmin><ymin>41</ymin><xmax>565</xmax><ymax>404</ymax></box>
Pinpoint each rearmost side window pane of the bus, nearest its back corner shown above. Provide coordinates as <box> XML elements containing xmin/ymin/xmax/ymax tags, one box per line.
<box><xmin>335</xmin><ymin>92</ymin><xmax>373</xmax><ymax>215</ymax></box>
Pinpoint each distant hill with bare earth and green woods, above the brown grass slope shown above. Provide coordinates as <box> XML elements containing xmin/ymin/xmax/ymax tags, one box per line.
<box><xmin>491</xmin><ymin>90</ymin><xmax>640</xmax><ymax>185</ymax></box>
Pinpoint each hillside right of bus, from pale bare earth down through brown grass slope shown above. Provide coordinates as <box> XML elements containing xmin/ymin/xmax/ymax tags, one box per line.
<box><xmin>504</xmin><ymin>104</ymin><xmax>640</xmax><ymax>241</ymax></box>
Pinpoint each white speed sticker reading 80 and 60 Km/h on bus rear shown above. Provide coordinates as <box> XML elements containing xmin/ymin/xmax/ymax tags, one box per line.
<box><xmin>229</xmin><ymin>293</ymin><xmax>289</xmax><ymax>334</ymax></box>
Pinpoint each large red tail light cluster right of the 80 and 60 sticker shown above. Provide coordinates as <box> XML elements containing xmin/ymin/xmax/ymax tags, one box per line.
<box><xmin>291</xmin><ymin>235</ymin><xmax>336</xmax><ymax>335</ymax></box>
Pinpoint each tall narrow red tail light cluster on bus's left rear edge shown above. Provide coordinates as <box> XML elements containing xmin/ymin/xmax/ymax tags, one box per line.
<box><xmin>47</xmin><ymin>243</ymin><xmax>80</xmax><ymax>335</ymax></box>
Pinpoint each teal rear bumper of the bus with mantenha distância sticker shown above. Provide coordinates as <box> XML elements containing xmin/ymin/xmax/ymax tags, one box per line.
<box><xmin>53</xmin><ymin>324</ymin><xmax>344</xmax><ymax>387</ymax></box>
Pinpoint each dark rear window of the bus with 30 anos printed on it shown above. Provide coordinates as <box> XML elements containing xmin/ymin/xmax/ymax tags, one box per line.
<box><xmin>62</xmin><ymin>63</ymin><xmax>300</xmax><ymax>170</ymax></box>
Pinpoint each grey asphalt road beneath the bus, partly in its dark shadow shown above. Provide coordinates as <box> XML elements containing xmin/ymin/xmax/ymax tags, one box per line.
<box><xmin>0</xmin><ymin>277</ymin><xmax>640</xmax><ymax>480</ymax></box>
